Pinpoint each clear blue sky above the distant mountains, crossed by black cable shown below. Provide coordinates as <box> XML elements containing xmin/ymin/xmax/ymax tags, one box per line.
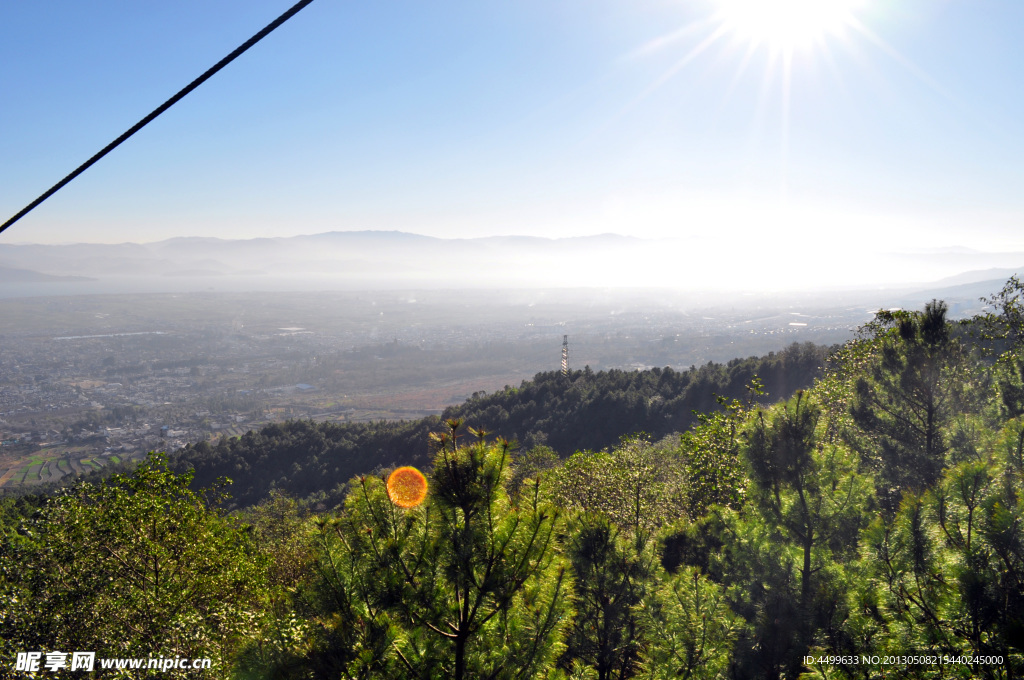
<box><xmin>0</xmin><ymin>0</ymin><xmax>1024</xmax><ymax>280</ymax></box>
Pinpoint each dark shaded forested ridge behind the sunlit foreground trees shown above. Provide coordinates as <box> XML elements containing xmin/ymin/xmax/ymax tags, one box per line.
<box><xmin>172</xmin><ymin>343</ymin><xmax>828</xmax><ymax>507</ymax></box>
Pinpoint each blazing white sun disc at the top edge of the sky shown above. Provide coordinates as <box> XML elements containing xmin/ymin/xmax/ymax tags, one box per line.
<box><xmin>716</xmin><ymin>0</ymin><xmax>863</xmax><ymax>52</ymax></box>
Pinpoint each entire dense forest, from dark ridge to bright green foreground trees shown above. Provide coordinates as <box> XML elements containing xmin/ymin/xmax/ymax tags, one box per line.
<box><xmin>0</xmin><ymin>279</ymin><xmax>1024</xmax><ymax>680</ymax></box>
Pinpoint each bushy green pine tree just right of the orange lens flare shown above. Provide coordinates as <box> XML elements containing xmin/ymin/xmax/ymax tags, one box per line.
<box><xmin>303</xmin><ymin>421</ymin><xmax>570</xmax><ymax>679</ymax></box>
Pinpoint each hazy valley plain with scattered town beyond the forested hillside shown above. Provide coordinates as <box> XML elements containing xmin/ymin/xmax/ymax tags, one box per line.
<box><xmin>0</xmin><ymin>259</ymin><xmax>1001</xmax><ymax>488</ymax></box>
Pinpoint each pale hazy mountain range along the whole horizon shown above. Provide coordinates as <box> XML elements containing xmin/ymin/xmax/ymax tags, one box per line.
<box><xmin>0</xmin><ymin>231</ymin><xmax>1024</xmax><ymax>296</ymax></box>
